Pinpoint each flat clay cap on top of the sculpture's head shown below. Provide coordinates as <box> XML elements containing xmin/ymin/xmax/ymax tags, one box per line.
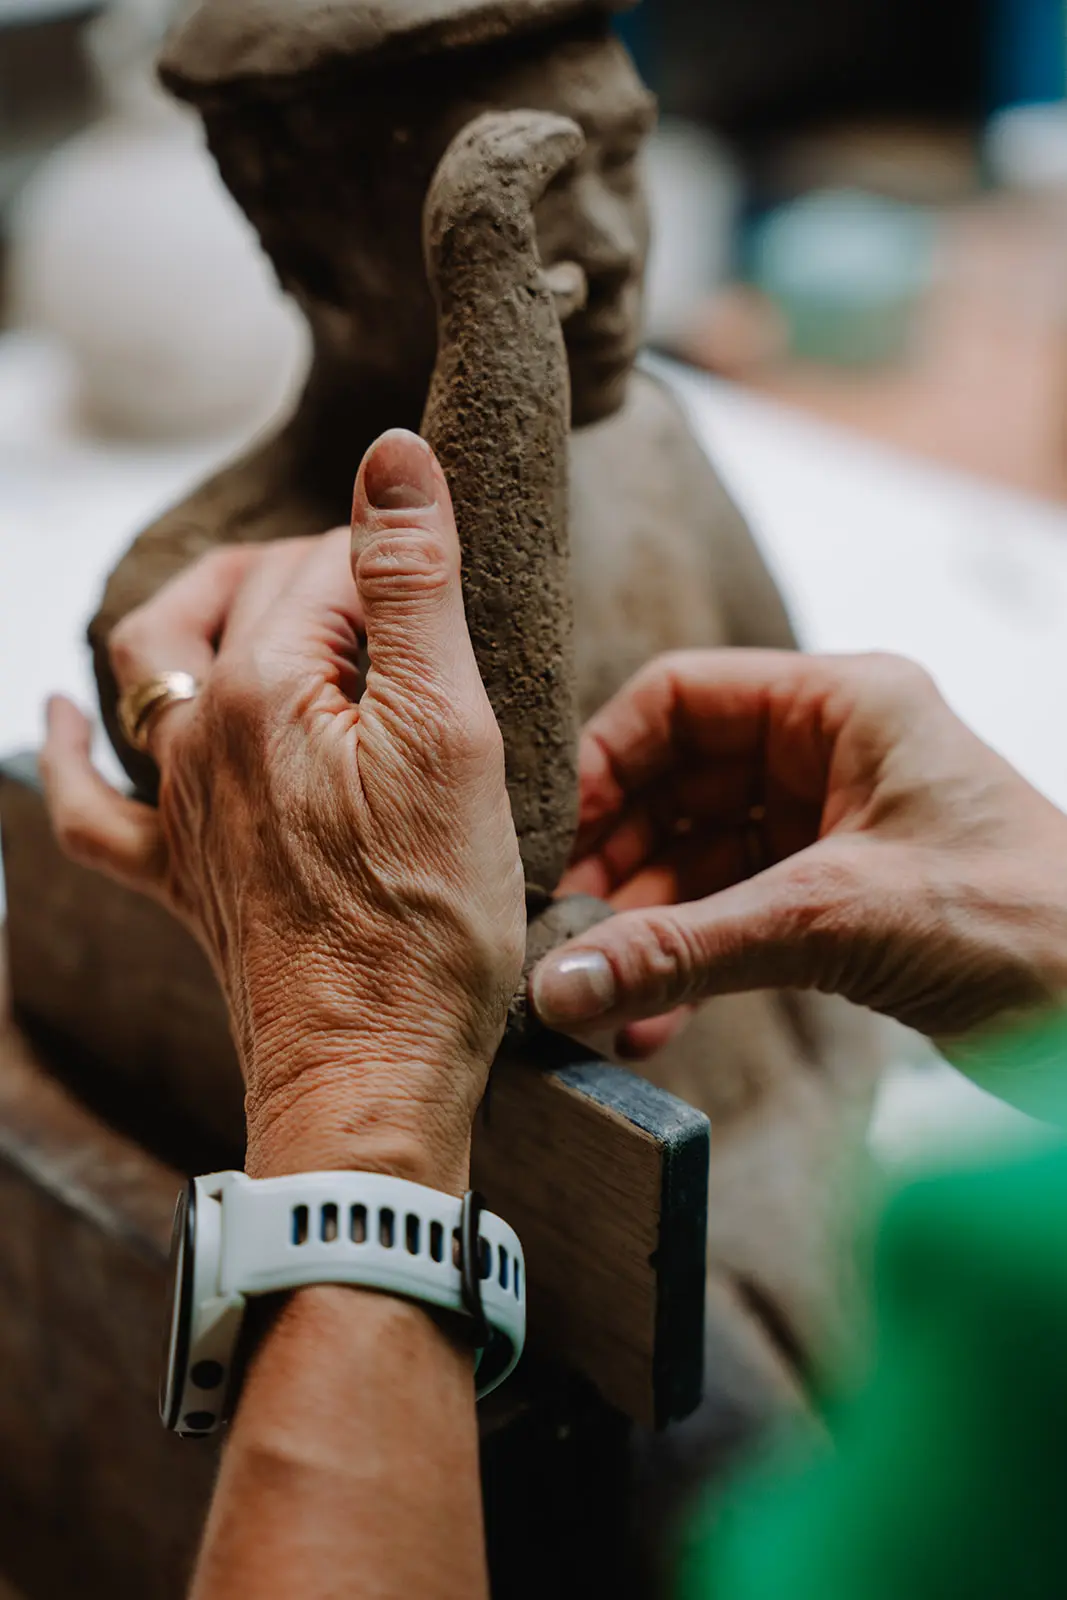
<box><xmin>160</xmin><ymin>0</ymin><xmax>635</xmax><ymax>99</ymax></box>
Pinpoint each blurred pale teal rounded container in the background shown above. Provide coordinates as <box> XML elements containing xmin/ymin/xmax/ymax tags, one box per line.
<box><xmin>752</xmin><ymin>189</ymin><xmax>934</xmax><ymax>366</ymax></box>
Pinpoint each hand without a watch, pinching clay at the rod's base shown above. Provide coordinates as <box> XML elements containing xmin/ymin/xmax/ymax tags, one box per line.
<box><xmin>531</xmin><ymin>650</ymin><xmax>1067</xmax><ymax>1042</ymax></box>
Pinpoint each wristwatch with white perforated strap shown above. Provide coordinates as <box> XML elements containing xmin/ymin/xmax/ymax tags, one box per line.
<box><xmin>160</xmin><ymin>1171</ymin><xmax>526</xmax><ymax>1437</ymax></box>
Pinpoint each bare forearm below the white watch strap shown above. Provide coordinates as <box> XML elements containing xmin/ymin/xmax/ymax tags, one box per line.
<box><xmin>192</xmin><ymin>1285</ymin><xmax>488</xmax><ymax>1600</ymax></box>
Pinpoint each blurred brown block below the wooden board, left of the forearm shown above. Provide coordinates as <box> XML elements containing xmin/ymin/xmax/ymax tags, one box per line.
<box><xmin>0</xmin><ymin>960</ymin><xmax>216</xmax><ymax>1600</ymax></box>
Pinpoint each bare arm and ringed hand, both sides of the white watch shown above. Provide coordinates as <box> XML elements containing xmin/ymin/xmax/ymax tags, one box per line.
<box><xmin>43</xmin><ymin>434</ymin><xmax>525</xmax><ymax>1600</ymax></box>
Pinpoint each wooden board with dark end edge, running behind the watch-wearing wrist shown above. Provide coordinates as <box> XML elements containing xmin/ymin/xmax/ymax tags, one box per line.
<box><xmin>0</xmin><ymin>757</ymin><xmax>709</xmax><ymax>1426</ymax></box>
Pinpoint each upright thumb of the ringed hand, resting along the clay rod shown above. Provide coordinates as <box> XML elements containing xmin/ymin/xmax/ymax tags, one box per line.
<box><xmin>352</xmin><ymin>429</ymin><xmax>477</xmax><ymax>696</ymax></box>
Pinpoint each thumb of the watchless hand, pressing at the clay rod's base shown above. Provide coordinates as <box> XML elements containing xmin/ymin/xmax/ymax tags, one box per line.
<box><xmin>530</xmin><ymin>845</ymin><xmax>870</xmax><ymax>1032</ymax></box>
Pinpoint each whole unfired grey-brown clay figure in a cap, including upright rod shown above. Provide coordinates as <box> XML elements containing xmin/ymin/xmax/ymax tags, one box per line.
<box><xmin>91</xmin><ymin>0</ymin><xmax>877</xmax><ymax>1442</ymax></box>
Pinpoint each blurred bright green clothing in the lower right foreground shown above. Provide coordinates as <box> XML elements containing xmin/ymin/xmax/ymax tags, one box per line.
<box><xmin>678</xmin><ymin>1035</ymin><xmax>1067</xmax><ymax>1600</ymax></box>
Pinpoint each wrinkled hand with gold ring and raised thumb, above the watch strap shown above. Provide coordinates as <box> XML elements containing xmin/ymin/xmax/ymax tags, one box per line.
<box><xmin>43</xmin><ymin>432</ymin><xmax>525</xmax><ymax>1192</ymax></box>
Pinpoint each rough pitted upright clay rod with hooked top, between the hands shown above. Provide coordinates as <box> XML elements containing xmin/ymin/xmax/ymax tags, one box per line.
<box><xmin>422</xmin><ymin>112</ymin><xmax>584</xmax><ymax>893</ymax></box>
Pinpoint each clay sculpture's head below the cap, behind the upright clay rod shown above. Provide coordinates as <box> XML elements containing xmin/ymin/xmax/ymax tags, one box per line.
<box><xmin>208</xmin><ymin>34</ymin><xmax>654</xmax><ymax>426</ymax></box>
